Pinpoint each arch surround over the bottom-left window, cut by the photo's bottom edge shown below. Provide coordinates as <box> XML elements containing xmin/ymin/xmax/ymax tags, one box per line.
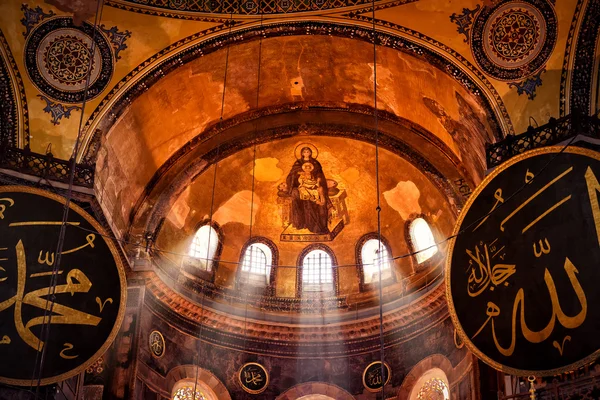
<box><xmin>166</xmin><ymin>365</ymin><xmax>231</xmax><ymax>400</ymax></box>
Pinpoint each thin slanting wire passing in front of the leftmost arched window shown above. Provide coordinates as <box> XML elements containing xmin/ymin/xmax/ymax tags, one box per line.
<box><xmin>192</xmin><ymin>9</ymin><xmax>234</xmax><ymax>400</ymax></box>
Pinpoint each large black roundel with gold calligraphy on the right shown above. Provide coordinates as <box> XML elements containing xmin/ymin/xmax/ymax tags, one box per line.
<box><xmin>446</xmin><ymin>147</ymin><xmax>600</xmax><ymax>376</ymax></box>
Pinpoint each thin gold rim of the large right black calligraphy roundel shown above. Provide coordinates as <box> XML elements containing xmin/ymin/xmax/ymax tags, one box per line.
<box><xmin>444</xmin><ymin>146</ymin><xmax>600</xmax><ymax>376</ymax></box>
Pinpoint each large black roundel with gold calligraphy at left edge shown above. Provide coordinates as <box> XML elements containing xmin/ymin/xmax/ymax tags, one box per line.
<box><xmin>0</xmin><ymin>186</ymin><xmax>126</xmax><ymax>385</ymax></box>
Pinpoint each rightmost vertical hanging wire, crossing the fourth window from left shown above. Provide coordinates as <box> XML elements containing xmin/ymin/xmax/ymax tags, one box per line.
<box><xmin>372</xmin><ymin>0</ymin><xmax>386</xmax><ymax>399</ymax></box>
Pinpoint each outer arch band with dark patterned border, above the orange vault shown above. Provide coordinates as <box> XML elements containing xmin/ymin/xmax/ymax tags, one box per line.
<box><xmin>78</xmin><ymin>20</ymin><xmax>514</xmax><ymax>164</ymax></box>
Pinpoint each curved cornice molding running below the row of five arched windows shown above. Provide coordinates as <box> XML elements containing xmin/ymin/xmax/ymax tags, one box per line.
<box><xmin>145</xmin><ymin>273</ymin><xmax>449</xmax><ymax>357</ymax></box>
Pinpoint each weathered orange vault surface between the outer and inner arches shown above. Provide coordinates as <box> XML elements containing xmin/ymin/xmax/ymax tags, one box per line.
<box><xmin>95</xmin><ymin>36</ymin><xmax>498</xmax><ymax>241</ymax></box>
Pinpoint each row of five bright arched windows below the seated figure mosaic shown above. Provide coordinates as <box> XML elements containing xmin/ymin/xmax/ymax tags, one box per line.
<box><xmin>188</xmin><ymin>218</ymin><xmax>438</xmax><ymax>292</ymax></box>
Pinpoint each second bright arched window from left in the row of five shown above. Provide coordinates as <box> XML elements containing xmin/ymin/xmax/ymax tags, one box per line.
<box><xmin>239</xmin><ymin>242</ymin><xmax>274</xmax><ymax>286</ymax></box>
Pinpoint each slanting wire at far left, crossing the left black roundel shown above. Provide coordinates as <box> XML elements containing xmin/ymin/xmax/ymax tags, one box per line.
<box><xmin>29</xmin><ymin>0</ymin><xmax>104</xmax><ymax>399</ymax></box>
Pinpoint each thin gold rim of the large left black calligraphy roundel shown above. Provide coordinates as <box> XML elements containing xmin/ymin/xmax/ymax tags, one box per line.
<box><xmin>0</xmin><ymin>185</ymin><xmax>127</xmax><ymax>386</ymax></box>
